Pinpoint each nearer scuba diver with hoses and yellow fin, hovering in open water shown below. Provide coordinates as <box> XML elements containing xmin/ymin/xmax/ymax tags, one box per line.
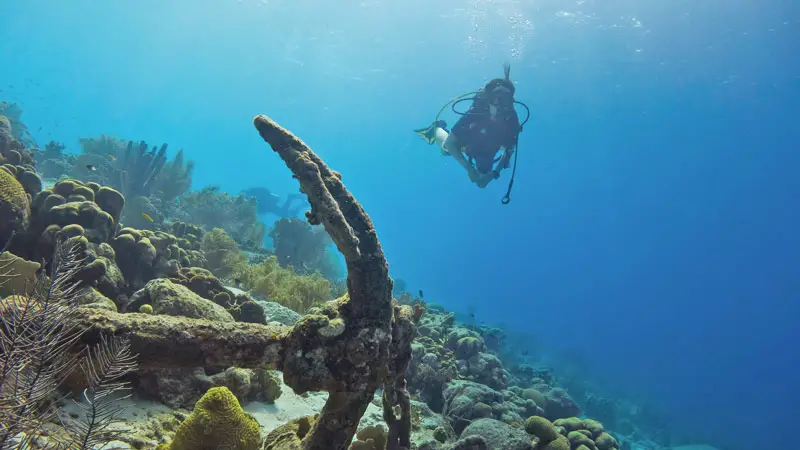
<box><xmin>414</xmin><ymin>63</ymin><xmax>530</xmax><ymax>204</ymax></box>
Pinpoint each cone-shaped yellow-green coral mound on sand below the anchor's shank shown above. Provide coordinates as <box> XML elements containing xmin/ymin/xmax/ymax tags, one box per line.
<box><xmin>157</xmin><ymin>387</ymin><xmax>261</xmax><ymax>450</ymax></box>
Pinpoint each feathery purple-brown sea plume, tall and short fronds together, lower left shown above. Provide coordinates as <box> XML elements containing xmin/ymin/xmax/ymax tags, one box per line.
<box><xmin>0</xmin><ymin>237</ymin><xmax>134</xmax><ymax>449</ymax></box>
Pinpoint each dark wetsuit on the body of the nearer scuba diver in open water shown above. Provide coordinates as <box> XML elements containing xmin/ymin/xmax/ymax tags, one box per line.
<box><xmin>451</xmin><ymin>91</ymin><xmax>520</xmax><ymax>173</ymax></box>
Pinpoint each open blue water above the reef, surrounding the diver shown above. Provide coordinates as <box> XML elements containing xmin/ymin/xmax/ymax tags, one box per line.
<box><xmin>0</xmin><ymin>0</ymin><xmax>800</xmax><ymax>449</ymax></box>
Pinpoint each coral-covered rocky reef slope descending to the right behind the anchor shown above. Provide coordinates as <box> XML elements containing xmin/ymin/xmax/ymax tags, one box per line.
<box><xmin>0</xmin><ymin>104</ymin><xmax>710</xmax><ymax>450</ymax></box>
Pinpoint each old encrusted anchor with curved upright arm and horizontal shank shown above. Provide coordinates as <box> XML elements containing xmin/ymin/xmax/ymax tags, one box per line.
<box><xmin>71</xmin><ymin>116</ymin><xmax>414</xmax><ymax>450</ymax></box>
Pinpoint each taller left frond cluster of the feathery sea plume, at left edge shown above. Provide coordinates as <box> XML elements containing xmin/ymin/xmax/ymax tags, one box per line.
<box><xmin>0</xmin><ymin>236</ymin><xmax>82</xmax><ymax>448</ymax></box>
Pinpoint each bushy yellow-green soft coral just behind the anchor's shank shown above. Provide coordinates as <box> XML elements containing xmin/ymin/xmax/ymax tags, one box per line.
<box><xmin>233</xmin><ymin>256</ymin><xmax>332</xmax><ymax>313</ymax></box>
